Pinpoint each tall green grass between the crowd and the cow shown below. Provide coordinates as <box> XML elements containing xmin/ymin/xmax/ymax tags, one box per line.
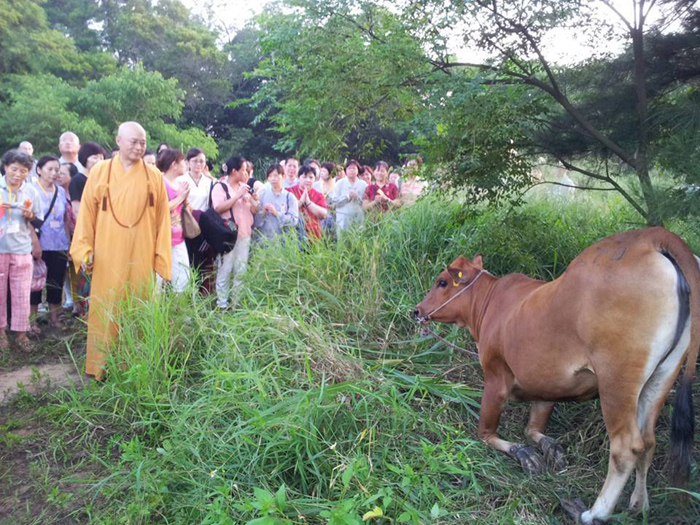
<box><xmin>46</xmin><ymin>195</ymin><xmax>697</xmax><ymax>525</ymax></box>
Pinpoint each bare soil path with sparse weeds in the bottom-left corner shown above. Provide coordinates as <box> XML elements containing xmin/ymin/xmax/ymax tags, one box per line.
<box><xmin>0</xmin><ymin>319</ymin><xmax>106</xmax><ymax>525</ymax></box>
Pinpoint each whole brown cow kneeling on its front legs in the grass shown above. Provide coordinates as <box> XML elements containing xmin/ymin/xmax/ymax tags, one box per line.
<box><xmin>414</xmin><ymin>228</ymin><xmax>700</xmax><ymax>523</ymax></box>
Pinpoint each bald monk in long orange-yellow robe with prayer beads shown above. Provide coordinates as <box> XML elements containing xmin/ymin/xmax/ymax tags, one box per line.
<box><xmin>70</xmin><ymin>122</ymin><xmax>172</xmax><ymax>380</ymax></box>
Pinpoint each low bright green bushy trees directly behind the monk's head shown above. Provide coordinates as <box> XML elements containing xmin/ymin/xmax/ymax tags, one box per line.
<box><xmin>0</xmin><ymin>66</ymin><xmax>218</xmax><ymax>157</ymax></box>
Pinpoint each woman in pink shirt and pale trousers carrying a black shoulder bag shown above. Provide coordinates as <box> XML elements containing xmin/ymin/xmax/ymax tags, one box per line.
<box><xmin>211</xmin><ymin>156</ymin><xmax>258</xmax><ymax>308</ymax></box>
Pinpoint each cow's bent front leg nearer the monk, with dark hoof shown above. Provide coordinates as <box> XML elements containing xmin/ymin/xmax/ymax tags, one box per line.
<box><xmin>479</xmin><ymin>371</ymin><xmax>544</xmax><ymax>474</ymax></box>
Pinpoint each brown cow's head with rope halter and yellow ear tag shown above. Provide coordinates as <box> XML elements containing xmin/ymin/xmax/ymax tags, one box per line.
<box><xmin>413</xmin><ymin>255</ymin><xmax>486</xmax><ymax>326</ymax></box>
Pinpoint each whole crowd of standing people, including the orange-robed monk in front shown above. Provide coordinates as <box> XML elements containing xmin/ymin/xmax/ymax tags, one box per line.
<box><xmin>0</xmin><ymin>122</ymin><xmax>422</xmax><ymax>379</ymax></box>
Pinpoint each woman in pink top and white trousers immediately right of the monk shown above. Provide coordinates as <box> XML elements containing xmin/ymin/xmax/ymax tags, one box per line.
<box><xmin>156</xmin><ymin>149</ymin><xmax>190</xmax><ymax>292</ymax></box>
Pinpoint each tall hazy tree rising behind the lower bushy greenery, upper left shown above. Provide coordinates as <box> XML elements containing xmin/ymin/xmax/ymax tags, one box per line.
<box><xmin>46</xmin><ymin>0</ymin><xmax>229</xmax><ymax>129</ymax></box>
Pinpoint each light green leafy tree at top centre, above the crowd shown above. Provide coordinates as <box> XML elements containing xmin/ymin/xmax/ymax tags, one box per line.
<box><xmin>253</xmin><ymin>2</ymin><xmax>428</xmax><ymax>157</ymax></box>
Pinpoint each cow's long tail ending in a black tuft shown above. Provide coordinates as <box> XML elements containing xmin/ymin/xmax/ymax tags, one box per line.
<box><xmin>660</xmin><ymin>231</ymin><xmax>700</xmax><ymax>487</ymax></box>
